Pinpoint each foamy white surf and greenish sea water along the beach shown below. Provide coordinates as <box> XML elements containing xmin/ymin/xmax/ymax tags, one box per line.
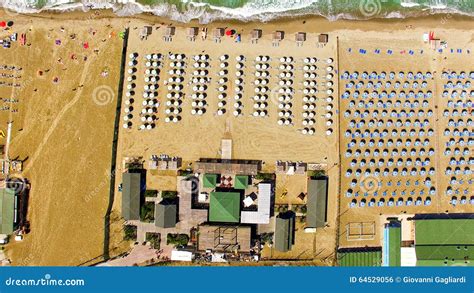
<box><xmin>0</xmin><ymin>0</ymin><xmax>474</xmax><ymax>24</ymax></box>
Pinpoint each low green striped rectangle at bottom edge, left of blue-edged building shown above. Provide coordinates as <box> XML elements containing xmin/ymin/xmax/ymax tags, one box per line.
<box><xmin>337</xmin><ymin>247</ymin><xmax>382</xmax><ymax>267</ymax></box>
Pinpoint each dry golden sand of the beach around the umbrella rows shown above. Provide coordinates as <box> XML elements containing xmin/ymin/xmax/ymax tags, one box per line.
<box><xmin>0</xmin><ymin>11</ymin><xmax>474</xmax><ymax>266</ymax></box>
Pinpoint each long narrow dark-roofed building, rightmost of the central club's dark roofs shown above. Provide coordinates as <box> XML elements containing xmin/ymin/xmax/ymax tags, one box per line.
<box><xmin>306</xmin><ymin>177</ymin><xmax>328</xmax><ymax>228</ymax></box>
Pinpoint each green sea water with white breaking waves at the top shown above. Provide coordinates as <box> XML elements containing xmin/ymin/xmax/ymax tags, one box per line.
<box><xmin>0</xmin><ymin>0</ymin><xmax>474</xmax><ymax>22</ymax></box>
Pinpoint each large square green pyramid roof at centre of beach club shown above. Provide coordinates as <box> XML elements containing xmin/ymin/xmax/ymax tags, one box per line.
<box><xmin>209</xmin><ymin>192</ymin><xmax>240</xmax><ymax>223</ymax></box>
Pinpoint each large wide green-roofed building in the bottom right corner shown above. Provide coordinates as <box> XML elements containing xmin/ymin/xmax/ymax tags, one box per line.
<box><xmin>415</xmin><ymin>218</ymin><xmax>474</xmax><ymax>266</ymax></box>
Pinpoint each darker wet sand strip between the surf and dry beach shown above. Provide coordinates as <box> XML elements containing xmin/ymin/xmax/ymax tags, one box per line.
<box><xmin>5</xmin><ymin>8</ymin><xmax>474</xmax><ymax>33</ymax></box>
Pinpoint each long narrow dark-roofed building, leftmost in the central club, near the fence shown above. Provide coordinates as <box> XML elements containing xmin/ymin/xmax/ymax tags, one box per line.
<box><xmin>122</xmin><ymin>173</ymin><xmax>142</xmax><ymax>221</ymax></box>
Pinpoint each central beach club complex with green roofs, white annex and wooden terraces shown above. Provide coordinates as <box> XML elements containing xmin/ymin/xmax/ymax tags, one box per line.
<box><xmin>189</xmin><ymin>159</ymin><xmax>278</xmax><ymax>253</ymax></box>
